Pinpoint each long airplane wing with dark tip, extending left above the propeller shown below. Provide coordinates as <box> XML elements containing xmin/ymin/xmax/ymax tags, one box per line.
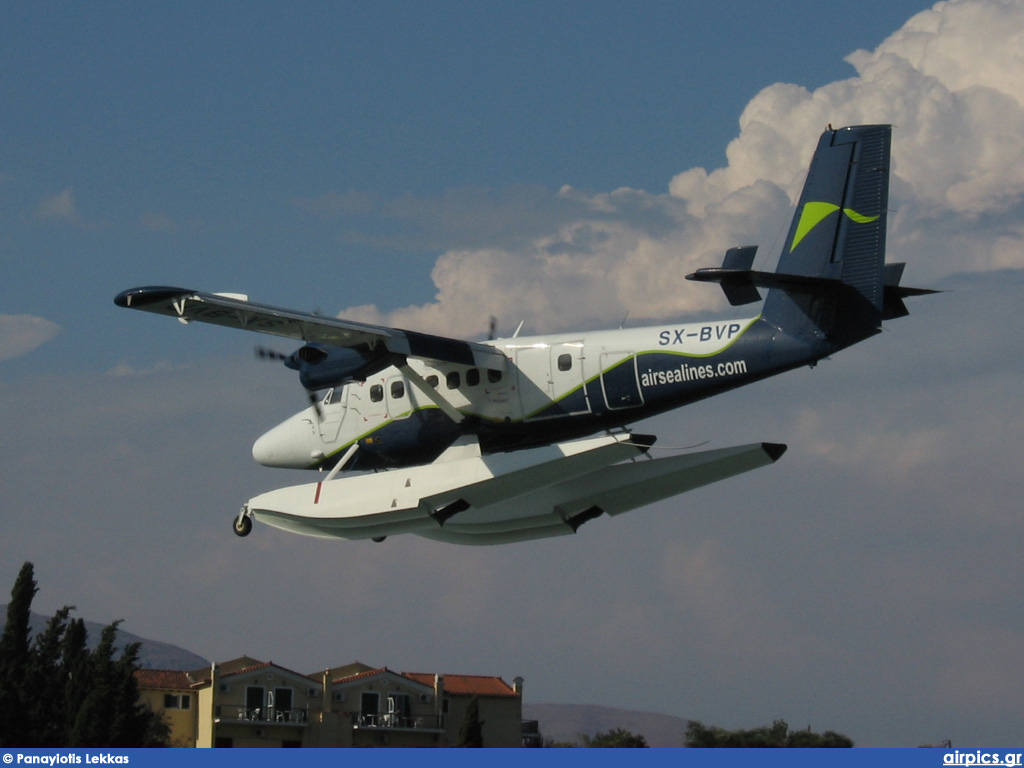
<box><xmin>114</xmin><ymin>286</ymin><xmax>506</xmax><ymax>371</ymax></box>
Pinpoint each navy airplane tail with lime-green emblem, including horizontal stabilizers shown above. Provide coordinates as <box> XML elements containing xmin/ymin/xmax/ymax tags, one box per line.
<box><xmin>687</xmin><ymin>125</ymin><xmax>930</xmax><ymax>346</ymax></box>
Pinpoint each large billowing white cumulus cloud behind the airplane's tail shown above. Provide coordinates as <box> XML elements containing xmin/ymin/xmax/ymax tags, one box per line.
<box><xmin>340</xmin><ymin>0</ymin><xmax>1024</xmax><ymax>336</ymax></box>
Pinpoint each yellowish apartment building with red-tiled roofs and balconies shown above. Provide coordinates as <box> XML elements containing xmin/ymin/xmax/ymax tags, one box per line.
<box><xmin>137</xmin><ymin>656</ymin><xmax>523</xmax><ymax>748</ymax></box>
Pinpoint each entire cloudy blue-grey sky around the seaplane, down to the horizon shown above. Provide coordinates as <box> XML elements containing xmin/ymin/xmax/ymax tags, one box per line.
<box><xmin>0</xmin><ymin>0</ymin><xmax>1024</xmax><ymax>746</ymax></box>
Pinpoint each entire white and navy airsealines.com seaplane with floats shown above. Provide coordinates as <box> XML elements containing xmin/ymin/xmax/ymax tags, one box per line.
<box><xmin>114</xmin><ymin>125</ymin><xmax>935</xmax><ymax>545</ymax></box>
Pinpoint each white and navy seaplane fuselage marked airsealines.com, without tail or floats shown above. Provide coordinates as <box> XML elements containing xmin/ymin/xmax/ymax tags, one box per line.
<box><xmin>253</xmin><ymin>316</ymin><xmax>830</xmax><ymax>470</ymax></box>
